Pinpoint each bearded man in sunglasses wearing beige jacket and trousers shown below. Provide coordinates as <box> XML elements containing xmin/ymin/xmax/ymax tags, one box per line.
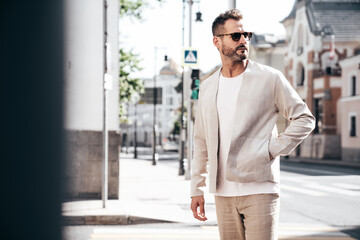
<box><xmin>191</xmin><ymin>9</ymin><xmax>314</xmax><ymax>240</ymax></box>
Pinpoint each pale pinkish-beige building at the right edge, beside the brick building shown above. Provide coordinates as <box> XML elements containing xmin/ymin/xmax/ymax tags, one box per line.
<box><xmin>337</xmin><ymin>55</ymin><xmax>360</xmax><ymax>162</ymax></box>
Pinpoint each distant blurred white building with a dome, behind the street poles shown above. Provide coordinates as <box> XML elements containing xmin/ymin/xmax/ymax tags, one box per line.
<box><xmin>121</xmin><ymin>59</ymin><xmax>181</xmax><ymax>147</ymax></box>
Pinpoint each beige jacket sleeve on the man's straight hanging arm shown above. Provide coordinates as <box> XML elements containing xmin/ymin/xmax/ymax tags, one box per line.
<box><xmin>191</xmin><ymin>92</ymin><xmax>208</xmax><ymax>197</ymax></box>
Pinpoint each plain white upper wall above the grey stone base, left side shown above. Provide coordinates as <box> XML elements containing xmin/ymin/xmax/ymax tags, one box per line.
<box><xmin>65</xmin><ymin>0</ymin><xmax>119</xmax><ymax>131</ymax></box>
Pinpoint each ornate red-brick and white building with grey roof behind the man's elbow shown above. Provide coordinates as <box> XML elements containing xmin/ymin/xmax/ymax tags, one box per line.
<box><xmin>282</xmin><ymin>0</ymin><xmax>360</xmax><ymax>159</ymax></box>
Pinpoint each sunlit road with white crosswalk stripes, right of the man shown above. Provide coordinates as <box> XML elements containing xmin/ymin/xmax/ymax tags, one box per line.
<box><xmin>280</xmin><ymin>162</ymin><xmax>360</xmax><ymax>227</ymax></box>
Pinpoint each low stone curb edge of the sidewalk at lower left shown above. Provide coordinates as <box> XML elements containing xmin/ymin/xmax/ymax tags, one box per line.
<box><xmin>62</xmin><ymin>215</ymin><xmax>174</xmax><ymax>226</ymax></box>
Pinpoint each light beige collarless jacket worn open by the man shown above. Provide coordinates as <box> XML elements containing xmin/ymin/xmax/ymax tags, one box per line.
<box><xmin>191</xmin><ymin>60</ymin><xmax>315</xmax><ymax>196</ymax></box>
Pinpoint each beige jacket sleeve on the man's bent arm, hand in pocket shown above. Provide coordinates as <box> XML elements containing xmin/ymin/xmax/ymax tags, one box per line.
<box><xmin>269</xmin><ymin>72</ymin><xmax>315</xmax><ymax>157</ymax></box>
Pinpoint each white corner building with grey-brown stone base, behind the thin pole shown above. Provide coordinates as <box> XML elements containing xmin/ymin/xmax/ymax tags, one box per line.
<box><xmin>64</xmin><ymin>0</ymin><xmax>121</xmax><ymax>199</ymax></box>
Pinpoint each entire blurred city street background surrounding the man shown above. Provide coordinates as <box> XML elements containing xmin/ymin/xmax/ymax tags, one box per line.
<box><xmin>0</xmin><ymin>0</ymin><xmax>360</xmax><ymax>239</ymax></box>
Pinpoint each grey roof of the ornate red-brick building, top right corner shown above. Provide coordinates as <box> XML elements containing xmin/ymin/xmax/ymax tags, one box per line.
<box><xmin>306</xmin><ymin>0</ymin><xmax>360</xmax><ymax>41</ymax></box>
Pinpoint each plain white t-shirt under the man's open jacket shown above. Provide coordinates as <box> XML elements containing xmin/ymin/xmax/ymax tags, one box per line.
<box><xmin>215</xmin><ymin>74</ymin><xmax>280</xmax><ymax>197</ymax></box>
